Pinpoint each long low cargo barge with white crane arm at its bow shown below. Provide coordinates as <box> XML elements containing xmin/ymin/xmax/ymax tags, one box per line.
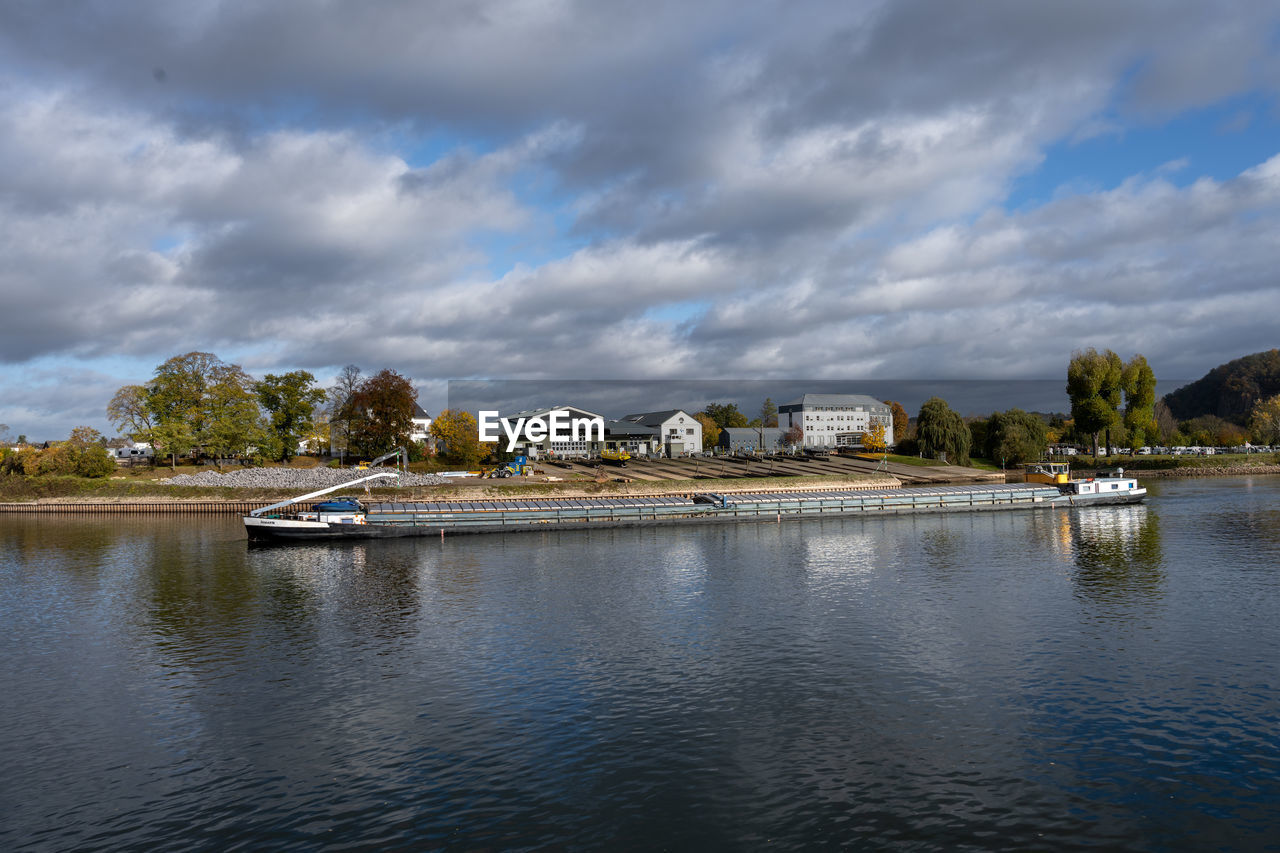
<box><xmin>244</xmin><ymin>474</ymin><xmax>1146</xmax><ymax>540</ymax></box>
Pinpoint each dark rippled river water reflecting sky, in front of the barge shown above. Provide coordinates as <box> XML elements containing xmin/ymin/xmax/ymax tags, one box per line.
<box><xmin>0</xmin><ymin>478</ymin><xmax>1280</xmax><ymax>850</ymax></box>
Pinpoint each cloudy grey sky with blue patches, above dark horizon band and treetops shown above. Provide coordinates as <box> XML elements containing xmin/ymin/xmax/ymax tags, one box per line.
<box><xmin>0</xmin><ymin>0</ymin><xmax>1280</xmax><ymax>438</ymax></box>
